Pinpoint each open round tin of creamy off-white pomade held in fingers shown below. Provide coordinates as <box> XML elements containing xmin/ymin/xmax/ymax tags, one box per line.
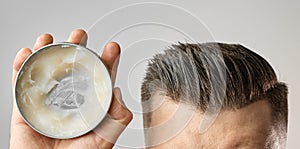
<box><xmin>15</xmin><ymin>43</ymin><xmax>112</xmax><ymax>138</ymax></box>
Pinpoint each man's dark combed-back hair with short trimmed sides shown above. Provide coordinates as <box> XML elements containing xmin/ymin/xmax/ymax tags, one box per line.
<box><xmin>141</xmin><ymin>43</ymin><xmax>288</xmax><ymax>148</ymax></box>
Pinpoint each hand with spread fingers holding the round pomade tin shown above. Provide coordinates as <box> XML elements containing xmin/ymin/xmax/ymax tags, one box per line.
<box><xmin>10</xmin><ymin>29</ymin><xmax>132</xmax><ymax>149</ymax></box>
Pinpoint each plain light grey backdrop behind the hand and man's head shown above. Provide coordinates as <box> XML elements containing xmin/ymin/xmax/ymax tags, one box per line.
<box><xmin>0</xmin><ymin>0</ymin><xmax>300</xmax><ymax>148</ymax></box>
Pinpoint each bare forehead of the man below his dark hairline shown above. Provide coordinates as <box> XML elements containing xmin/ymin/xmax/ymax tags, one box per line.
<box><xmin>146</xmin><ymin>100</ymin><xmax>271</xmax><ymax>148</ymax></box>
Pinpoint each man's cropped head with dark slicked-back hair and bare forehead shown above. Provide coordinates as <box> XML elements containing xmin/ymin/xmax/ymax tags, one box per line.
<box><xmin>141</xmin><ymin>43</ymin><xmax>288</xmax><ymax>148</ymax></box>
